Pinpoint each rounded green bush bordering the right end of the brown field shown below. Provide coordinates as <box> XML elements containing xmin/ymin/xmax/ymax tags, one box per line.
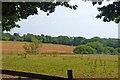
<box><xmin>73</xmin><ymin>45</ymin><xmax>96</xmax><ymax>54</ymax></box>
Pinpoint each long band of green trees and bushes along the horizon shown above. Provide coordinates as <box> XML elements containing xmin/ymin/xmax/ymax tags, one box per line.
<box><xmin>1</xmin><ymin>33</ymin><xmax>120</xmax><ymax>53</ymax></box>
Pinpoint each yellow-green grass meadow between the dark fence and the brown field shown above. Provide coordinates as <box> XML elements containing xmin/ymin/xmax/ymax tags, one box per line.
<box><xmin>2</xmin><ymin>54</ymin><xmax>118</xmax><ymax>78</ymax></box>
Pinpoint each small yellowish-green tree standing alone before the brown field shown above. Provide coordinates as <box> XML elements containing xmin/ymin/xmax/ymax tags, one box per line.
<box><xmin>23</xmin><ymin>39</ymin><xmax>41</xmax><ymax>57</ymax></box>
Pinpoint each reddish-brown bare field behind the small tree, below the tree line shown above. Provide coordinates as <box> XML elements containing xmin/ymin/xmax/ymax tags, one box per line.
<box><xmin>0</xmin><ymin>41</ymin><xmax>74</xmax><ymax>54</ymax></box>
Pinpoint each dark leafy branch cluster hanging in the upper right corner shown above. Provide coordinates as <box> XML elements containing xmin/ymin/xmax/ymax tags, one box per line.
<box><xmin>96</xmin><ymin>1</ymin><xmax>120</xmax><ymax>23</ymax></box>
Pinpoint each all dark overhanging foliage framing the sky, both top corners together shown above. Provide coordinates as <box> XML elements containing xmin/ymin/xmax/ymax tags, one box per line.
<box><xmin>2</xmin><ymin>0</ymin><xmax>120</xmax><ymax>31</ymax></box>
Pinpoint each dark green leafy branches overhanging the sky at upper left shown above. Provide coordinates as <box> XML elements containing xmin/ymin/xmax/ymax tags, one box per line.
<box><xmin>2</xmin><ymin>0</ymin><xmax>77</xmax><ymax>31</ymax></box>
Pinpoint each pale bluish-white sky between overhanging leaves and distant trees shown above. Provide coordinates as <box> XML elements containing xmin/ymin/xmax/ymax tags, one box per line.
<box><xmin>11</xmin><ymin>0</ymin><xmax>118</xmax><ymax>38</ymax></box>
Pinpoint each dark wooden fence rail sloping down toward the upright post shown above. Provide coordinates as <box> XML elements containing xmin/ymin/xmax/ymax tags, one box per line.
<box><xmin>0</xmin><ymin>70</ymin><xmax>71</xmax><ymax>80</ymax></box>
